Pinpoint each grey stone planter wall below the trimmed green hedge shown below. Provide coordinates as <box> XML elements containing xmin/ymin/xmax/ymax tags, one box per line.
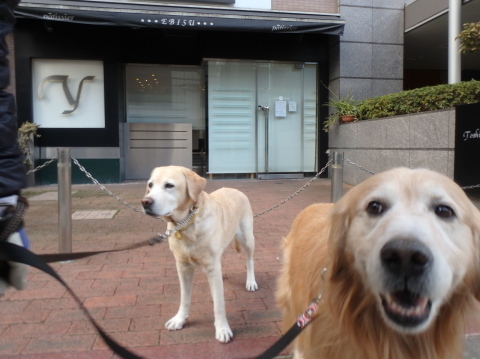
<box><xmin>329</xmin><ymin>109</ymin><xmax>455</xmax><ymax>185</ymax></box>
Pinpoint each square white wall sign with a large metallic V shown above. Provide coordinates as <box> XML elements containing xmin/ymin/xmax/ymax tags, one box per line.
<box><xmin>32</xmin><ymin>59</ymin><xmax>105</xmax><ymax>128</ymax></box>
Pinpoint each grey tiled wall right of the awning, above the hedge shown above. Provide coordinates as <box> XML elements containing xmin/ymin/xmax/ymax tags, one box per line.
<box><xmin>330</xmin><ymin>0</ymin><xmax>405</xmax><ymax>100</ymax></box>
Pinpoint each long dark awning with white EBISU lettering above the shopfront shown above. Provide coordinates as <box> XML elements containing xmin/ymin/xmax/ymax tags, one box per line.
<box><xmin>15</xmin><ymin>0</ymin><xmax>345</xmax><ymax>35</ymax></box>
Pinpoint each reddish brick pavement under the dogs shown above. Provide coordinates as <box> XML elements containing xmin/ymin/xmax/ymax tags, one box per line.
<box><xmin>0</xmin><ymin>179</ymin><xmax>480</xmax><ymax>359</ymax></box>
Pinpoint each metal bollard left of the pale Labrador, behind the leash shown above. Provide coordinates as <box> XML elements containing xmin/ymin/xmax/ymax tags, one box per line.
<box><xmin>57</xmin><ymin>148</ymin><xmax>72</xmax><ymax>253</ymax></box>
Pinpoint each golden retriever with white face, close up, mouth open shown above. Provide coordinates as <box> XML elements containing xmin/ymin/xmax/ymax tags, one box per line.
<box><xmin>277</xmin><ymin>168</ymin><xmax>480</xmax><ymax>359</ymax></box>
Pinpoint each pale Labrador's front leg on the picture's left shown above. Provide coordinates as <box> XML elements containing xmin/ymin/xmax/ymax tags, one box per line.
<box><xmin>165</xmin><ymin>262</ymin><xmax>195</xmax><ymax>330</ymax></box>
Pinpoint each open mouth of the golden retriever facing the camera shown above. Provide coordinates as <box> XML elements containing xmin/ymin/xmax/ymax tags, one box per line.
<box><xmin>381</xmin><ymin>290</ymin><xmax>432</xmax><ymax>327</ymax></box>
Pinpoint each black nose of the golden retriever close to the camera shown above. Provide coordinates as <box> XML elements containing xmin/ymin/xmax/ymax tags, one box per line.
<box><xmin>380</xmin><ymin>238</ymin><xmax>433</xmax><ymax>277</ymax></box>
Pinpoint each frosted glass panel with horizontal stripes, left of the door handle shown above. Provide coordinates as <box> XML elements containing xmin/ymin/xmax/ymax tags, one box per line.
<box><xmin>208</xmin><ymin>61</ymin><xmax>256</xmax><ymax>173</ymax></box>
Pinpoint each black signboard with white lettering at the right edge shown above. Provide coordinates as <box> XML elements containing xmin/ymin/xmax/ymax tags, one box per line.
<box><xmin>454</xmin><ymin>103</ymin><xmax>480</xmax><ymax>196</ymax></box>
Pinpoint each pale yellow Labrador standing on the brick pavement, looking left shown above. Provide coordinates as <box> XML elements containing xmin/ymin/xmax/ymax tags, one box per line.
<box><xmin>142</xmin><ymin>166</ymin><xmax>258</xmax><ymax>343</ymax></box>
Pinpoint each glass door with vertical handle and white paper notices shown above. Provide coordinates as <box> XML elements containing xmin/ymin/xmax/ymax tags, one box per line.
<box><xmin>257</xmin><ymin>63</ymin><xmax>317</xmax><ymax>178</ymax></box>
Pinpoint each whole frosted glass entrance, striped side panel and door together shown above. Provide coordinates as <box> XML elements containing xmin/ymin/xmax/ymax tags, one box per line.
<box><xmin>208</xmin><ymin>60</ymin><xmax>317</xmax><ymax>178</ymax></box>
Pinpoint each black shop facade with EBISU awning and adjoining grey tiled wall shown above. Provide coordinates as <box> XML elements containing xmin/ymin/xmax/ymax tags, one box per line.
<box><xmin>13</xmin><ymin>0</ymin><xmax>405</xmax><ymax>184</ymax></box>
